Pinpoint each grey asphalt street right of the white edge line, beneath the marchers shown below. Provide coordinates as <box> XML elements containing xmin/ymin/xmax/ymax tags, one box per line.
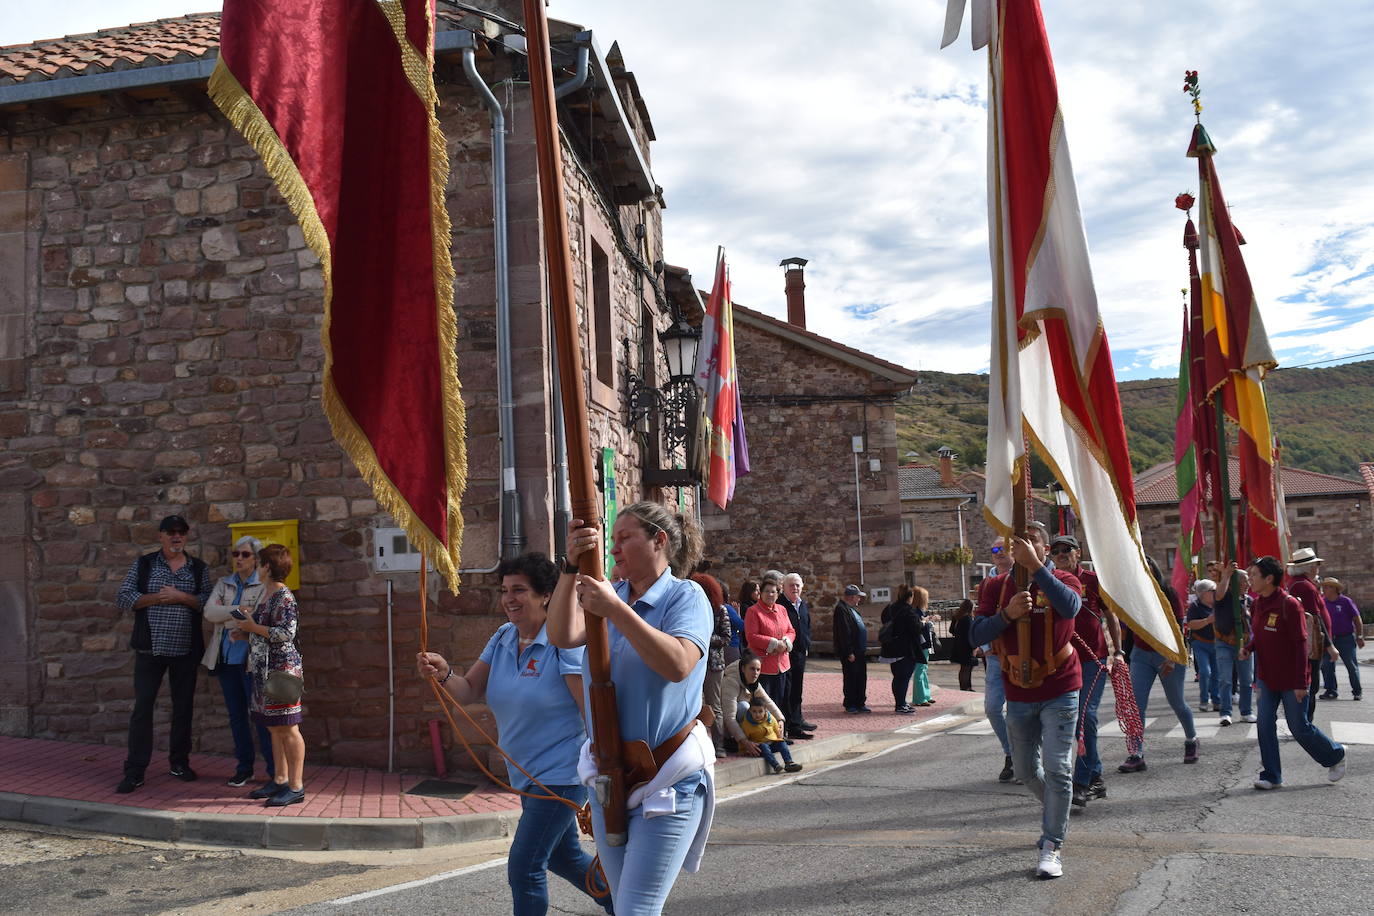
<box><xmin>278</xmin><ymin>685</ymin><xmax>1374</xmax><ymax>916</ymax></box>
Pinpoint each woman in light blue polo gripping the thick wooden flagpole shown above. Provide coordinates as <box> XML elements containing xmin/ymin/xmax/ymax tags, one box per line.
<box><xmin>548</xmin><ymin>503</ymin><xmax>716</xmax><ymax>916</ymax></box>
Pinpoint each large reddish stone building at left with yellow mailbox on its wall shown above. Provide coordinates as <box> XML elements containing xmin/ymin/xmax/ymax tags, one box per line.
<box><xmin>0</xmin><ymin>1</ymin><xmax>691</xmax><ymax>768</ymax></box>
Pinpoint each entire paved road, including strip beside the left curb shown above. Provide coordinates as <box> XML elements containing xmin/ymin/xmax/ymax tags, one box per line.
<box><xmin>0</xmin><ymin>687</ymin><xmax>1374</xmax><ymax>916</ymax></box>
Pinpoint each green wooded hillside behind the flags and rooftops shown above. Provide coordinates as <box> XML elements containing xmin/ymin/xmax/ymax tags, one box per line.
<box><xmin>897</xmin><ymin>360</ymin><xmax>1374</xmax><ymax>486</ymax></box>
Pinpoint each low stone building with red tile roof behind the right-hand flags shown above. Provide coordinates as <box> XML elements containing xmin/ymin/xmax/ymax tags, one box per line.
<box><xmin>1135</xmin><ymin>457</ymin><xmax>1374</xmax><ymax>610</ymax></box>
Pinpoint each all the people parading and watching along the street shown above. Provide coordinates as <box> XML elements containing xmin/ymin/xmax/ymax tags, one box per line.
<box><xmin>117</xmin><ymin>503</ymin><xmax>1364</xmax><ymax>913</ymax></box>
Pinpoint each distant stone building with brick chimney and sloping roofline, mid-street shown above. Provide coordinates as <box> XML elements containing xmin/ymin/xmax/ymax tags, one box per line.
<box><xmin>702</xmin><ymin>258</ymin><xmax>916</xmax><ymax>623</ymax></box>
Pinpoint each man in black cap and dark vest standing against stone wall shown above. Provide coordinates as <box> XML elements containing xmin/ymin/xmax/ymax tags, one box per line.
<box><xmin>114</xmin><ymin>515</ymin><xmax>213</xmax><ymax>794</ymax></box>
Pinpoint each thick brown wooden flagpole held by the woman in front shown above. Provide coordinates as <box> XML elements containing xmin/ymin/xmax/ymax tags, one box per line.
<box><xmin>525</xmin><ymin>0</ymin><xmax>627</xmax><ymax>846</ymax></box>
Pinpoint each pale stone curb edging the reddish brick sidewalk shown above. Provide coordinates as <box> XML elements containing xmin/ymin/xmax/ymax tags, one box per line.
<box><xmin>0</xmin><ymin>696</ymin><xmax>982</xmax><ymax>850</ymax></box>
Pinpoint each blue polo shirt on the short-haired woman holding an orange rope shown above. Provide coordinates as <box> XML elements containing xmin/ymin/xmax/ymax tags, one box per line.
<box><xmin>481</xmin><ymin>623</ymin><xmax>587</xmax><ymax>791</ymax></box>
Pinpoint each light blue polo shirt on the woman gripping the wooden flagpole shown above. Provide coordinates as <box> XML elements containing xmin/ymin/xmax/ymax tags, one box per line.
<box><xmin>583</xmin><ymin>570</ymin><xmax>714</xmax><ymax>747</ymax></box>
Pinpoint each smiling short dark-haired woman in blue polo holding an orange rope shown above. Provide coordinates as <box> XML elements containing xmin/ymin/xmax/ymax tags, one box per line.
<box><xmin>418</xmin><ymin>553</ymin><xmax>611</xmax><ymax>916</ymax></box>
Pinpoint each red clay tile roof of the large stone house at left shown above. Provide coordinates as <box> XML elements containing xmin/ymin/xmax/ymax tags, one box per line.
<box><xmin>0</xmin><ymin>12</ymin><xmax>220</xmax><ymax>85</ymax></box>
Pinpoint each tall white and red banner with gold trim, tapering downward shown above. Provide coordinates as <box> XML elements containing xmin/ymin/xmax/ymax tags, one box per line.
<box><xmin>944</xmin><ymin>0</ymin><xmax>1184</xmax><ymax>659</ymax></box>
